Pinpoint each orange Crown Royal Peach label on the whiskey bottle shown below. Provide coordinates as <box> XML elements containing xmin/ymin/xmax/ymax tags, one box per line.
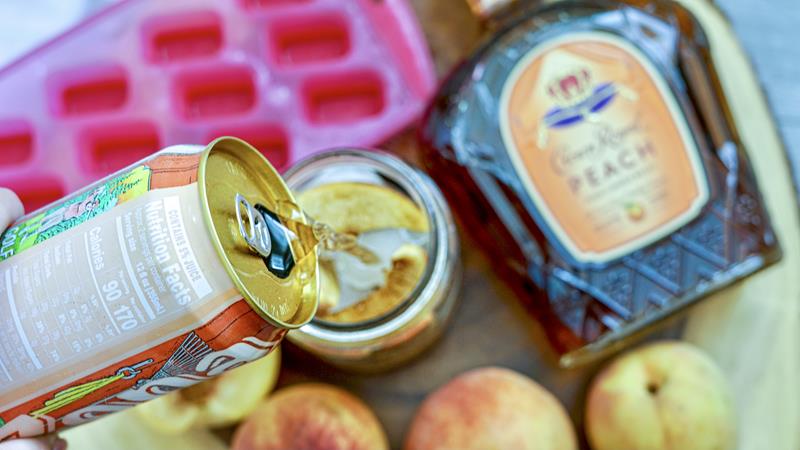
<box><xmin>500</xmin><ymin>32</ymin><xmax>709</xmax><ymax>263</ymax></box>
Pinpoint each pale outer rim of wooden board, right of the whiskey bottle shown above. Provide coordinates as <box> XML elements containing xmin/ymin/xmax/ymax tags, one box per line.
<box><xmin>682</xmin><ymin>0</ymin><xmax>800</xmax><ymax>450</ymax></box>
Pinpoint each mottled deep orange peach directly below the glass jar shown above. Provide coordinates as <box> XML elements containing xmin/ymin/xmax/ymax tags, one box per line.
<box><xmin>231</xmin><ymin>383</ymin><xmax>389</xmax><ymax>450</ymax></box>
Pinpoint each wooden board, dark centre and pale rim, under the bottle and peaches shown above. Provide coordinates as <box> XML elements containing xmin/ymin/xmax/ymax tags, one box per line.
<box><xmin>282</xmin><ymin>0</ymin><xmax>800</xmax><ymax>450</ymax></box>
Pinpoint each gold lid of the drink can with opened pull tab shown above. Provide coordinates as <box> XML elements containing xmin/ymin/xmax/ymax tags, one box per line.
<box><xmin>198</xmin><ymin>137</ymin><xmax>318</xmax><ymax>329</ymax></box>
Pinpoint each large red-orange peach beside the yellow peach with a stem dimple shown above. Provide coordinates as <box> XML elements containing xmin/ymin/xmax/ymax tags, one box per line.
<box><xmin>405</xmin><ymin>367</ymin><xmax>577</xmax><ymax>450</ymax></box>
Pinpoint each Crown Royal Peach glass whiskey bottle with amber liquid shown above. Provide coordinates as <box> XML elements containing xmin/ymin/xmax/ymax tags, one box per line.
<box><xmin>420</xmin><ymin>0</ymin><xmax>781</xmax><ymax>366</ymax></box>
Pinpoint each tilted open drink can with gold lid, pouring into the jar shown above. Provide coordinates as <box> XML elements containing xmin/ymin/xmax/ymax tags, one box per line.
<box><xmin>0</xmin><ymin>137</ymin><xmax>317</xmax><ymax>441</ymax></box>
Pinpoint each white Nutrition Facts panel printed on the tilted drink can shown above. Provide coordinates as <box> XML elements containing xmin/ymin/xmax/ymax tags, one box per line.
<box><xmin>0</xmin><ymin>186</ymin><xmax>231</xmax><ymax>394</ymax></box>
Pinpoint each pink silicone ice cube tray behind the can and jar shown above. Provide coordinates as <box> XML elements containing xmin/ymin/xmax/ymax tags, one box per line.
<box><xmin>0</xmin><ymin>0</ymin><xmax>435</xmax><ymax>211</ymax></box>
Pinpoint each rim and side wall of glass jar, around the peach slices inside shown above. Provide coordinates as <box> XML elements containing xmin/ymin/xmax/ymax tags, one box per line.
<box><xmin>285</xmin><ymin>149</ymin><xmax>462</xmax><ymax>372</ymax></box>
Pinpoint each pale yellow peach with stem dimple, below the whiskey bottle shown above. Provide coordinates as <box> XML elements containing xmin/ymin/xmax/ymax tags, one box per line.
<box><xmin>586</xmin><ymin>341</ymin><xmax>735</xmax><ymax>450</ymax></box>
